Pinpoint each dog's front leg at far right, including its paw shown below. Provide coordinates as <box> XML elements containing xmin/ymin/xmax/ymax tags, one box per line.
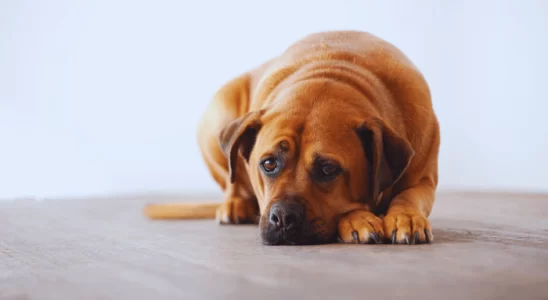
<box><xmin>383</xmin><ymin>180</ymin><xmax>435</xmax><ymax>244</ymax></box>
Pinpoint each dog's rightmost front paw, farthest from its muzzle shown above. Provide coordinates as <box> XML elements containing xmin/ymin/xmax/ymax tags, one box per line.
<box><xmin>383</xmin><ymin>212</ymin><xmax>434</xmax><ymax>245</ymax></box>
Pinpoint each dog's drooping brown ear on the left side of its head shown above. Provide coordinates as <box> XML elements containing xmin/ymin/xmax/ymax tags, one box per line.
<box><xmin>219</xmin><ymin>111</ymin><xmax>262</xmax><ymax>183</ymax></box>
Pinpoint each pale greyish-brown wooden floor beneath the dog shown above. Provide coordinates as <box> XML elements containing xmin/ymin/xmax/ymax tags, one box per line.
<box><xmin>0</xmin><ymin>193</ymin><xmax>548</xmax><ymax>300</ymax></box>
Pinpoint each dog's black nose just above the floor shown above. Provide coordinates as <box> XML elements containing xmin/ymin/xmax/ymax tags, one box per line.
<box><xmin>269</xmin><ymin>200</ymin><xmax>304</xmax><ymax>231</ymax></box>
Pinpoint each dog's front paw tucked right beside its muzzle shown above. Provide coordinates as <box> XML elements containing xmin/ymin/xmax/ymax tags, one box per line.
<box><xmin>339</xmin><ymin>210</ymin><xmax>384</xmax><ymax>244</ymax></box>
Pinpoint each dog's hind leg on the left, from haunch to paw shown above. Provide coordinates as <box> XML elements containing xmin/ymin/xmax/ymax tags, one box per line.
<box><xmin>198</xmin><ymin>74</ymin><xmax>259</xmax><ymax>224</ymax></box>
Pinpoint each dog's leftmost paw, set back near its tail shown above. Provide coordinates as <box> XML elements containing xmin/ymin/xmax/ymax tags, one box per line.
<box><xmin>216</xmin><ymin>197</ymin><xmax>259</xmax><ymax>225</ymax></box>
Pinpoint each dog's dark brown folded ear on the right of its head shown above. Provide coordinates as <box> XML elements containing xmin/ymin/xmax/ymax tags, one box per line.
<box><xmin>357</xmin><ymin>119</ymin><xmax>415</xmax><ymax>201</ymax></box>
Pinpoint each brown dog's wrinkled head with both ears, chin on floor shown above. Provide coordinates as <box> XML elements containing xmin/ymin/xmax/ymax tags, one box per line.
<box><xmin>220</xmin><ymin>82</ymin><xmax>413</xmax><ymax>244</ymax></box>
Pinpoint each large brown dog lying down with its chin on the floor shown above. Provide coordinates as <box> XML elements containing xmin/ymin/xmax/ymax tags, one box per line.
<box><xmin>143</xmin><ymin>31</ymin><xmax>440</xmax><ymax>244</ymax></box>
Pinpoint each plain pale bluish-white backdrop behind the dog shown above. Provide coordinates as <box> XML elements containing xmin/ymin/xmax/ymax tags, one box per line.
<box><xmin>0</xmin><ymin>0</ymin><xmax>548</xmax><ymax>198</ymax></box>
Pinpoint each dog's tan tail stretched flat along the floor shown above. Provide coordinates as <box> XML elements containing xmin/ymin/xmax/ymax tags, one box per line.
<box><xmin>144</xmin><ymin>203</ymin><xmax>220</xmax><ymax>220</ymax></box>
